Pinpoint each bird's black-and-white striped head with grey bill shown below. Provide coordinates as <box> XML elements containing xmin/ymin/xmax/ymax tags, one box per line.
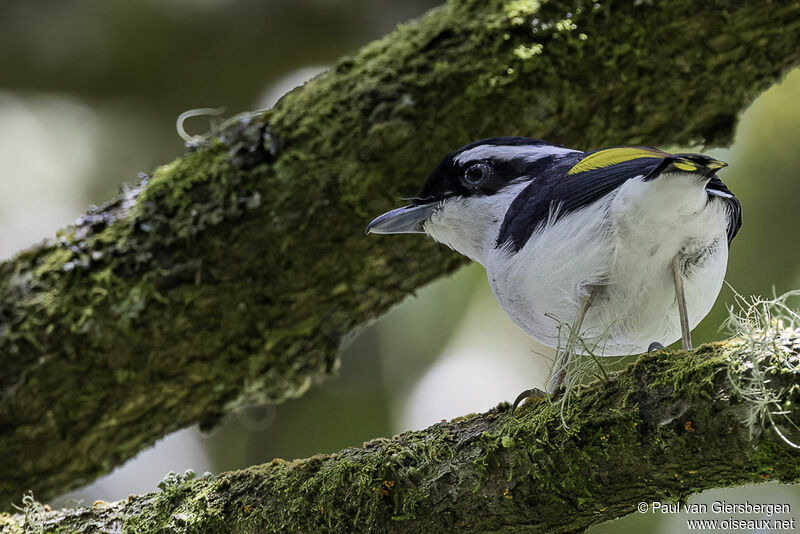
<box><xmin>367</xmin><ymin>137</ymin><xmax>581</xmax><ymax>262</ymax></box>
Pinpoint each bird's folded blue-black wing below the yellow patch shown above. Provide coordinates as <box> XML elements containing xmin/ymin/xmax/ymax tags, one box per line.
<box><xmin>496</xmin><ymin>154</ymin><xmax>664</xmax><ymax>252</ymax></box>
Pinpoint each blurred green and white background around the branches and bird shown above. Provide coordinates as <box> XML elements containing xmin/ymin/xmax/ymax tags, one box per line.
<box><xmin>0</xmin><ymin>0</ymin><xmax>800</xmax><ymax>534</ymax></box>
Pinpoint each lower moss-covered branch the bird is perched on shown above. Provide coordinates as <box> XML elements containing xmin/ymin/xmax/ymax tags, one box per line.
<box><xmin>0</xmin><ymin>342</ymin><xmax>800</xmax><ymax>534</ymax></box>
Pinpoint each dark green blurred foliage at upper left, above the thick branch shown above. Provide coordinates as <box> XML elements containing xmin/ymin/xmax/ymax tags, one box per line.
<box><xmin>0</xmin><ymin>0</ymin><xmax>438</xmax><ymax>202</ymax></box>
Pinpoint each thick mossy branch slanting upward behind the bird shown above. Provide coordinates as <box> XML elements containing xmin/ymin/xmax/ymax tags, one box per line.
<box><xmin>0</xmin><ymin>0</ymin><xmax>800</xmax><ymax>510</ymax></box>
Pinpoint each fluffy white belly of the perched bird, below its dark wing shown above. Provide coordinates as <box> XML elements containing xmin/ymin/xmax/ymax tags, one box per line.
<box><xmin>485</xmin><ymin>174</ymin><xmax>728</xmax><ymax>356</ymax></box>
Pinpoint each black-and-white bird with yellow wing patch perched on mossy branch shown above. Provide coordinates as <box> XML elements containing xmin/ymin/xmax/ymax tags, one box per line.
<box><xmin>366</xmin><ymin>137</ymin><xmax>742</xmax><ymax>398</ymax></box>
